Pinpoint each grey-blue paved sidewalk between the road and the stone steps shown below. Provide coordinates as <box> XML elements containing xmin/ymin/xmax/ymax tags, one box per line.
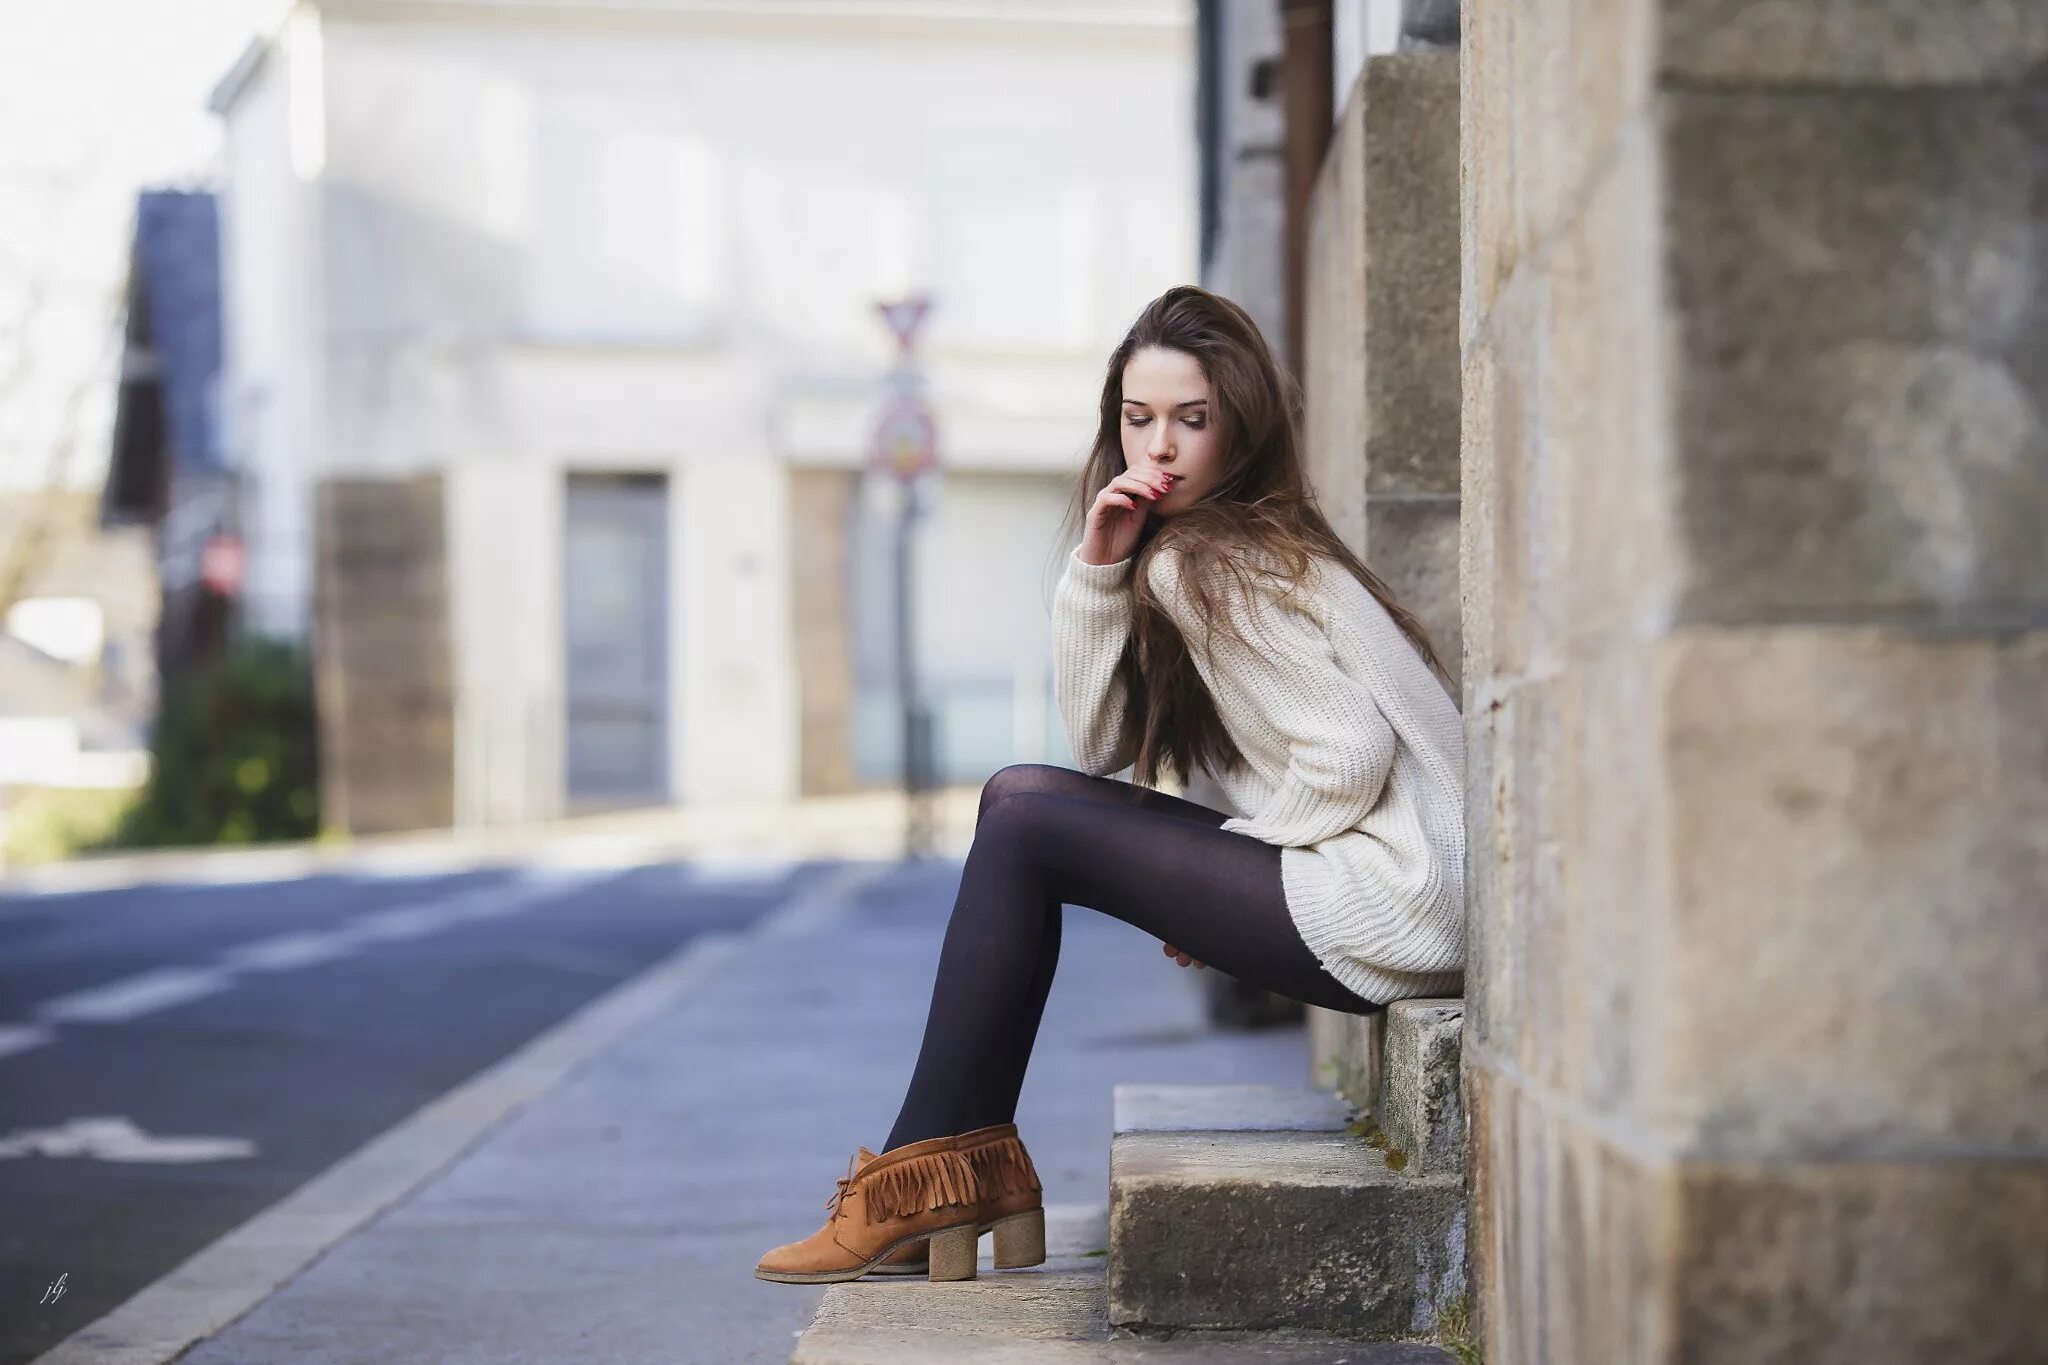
<box><xmin>43</xmin><ymin>860</ymin><xmax>1307</xmax><ymax>1365</ymax></box>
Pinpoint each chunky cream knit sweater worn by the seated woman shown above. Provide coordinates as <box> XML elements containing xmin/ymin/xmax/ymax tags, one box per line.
<box><xmin>1053</xmin><ymin>546</ymin><xmax>1464</xmax><ymax>1005</ymax></box>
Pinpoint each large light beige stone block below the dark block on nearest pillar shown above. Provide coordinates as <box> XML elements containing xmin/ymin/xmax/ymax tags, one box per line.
<box><xmin>1647</xmin><ymin>626</ymin><xmax>2048</xmax><ymax>1160</ymax></box>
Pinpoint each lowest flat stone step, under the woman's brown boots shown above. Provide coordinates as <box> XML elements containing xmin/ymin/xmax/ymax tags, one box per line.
<box><xmin>791</xmin><ymin>1203</ymin><xmax>1454</xmax><ymax>1365</ymax></box>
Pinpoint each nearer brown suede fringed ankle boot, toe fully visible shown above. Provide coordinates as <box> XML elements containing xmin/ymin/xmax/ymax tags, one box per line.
<box><xmin>754</xmin><ymin>1138</ymin><xmax>977</xmax><ymax>1285</ymax></box>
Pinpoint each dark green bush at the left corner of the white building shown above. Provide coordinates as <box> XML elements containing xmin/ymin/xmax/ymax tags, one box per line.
<box><xmin>102</xmin><ymin>636</ymin><xmax>319</xmax><ymax>847</ymax></box>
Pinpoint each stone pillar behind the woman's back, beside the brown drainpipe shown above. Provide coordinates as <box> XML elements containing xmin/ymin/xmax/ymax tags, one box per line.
<box><xmin>1303</xmin><ymin>51</ymin><xmax>1462</xmax><ymax>1105</ymax></box>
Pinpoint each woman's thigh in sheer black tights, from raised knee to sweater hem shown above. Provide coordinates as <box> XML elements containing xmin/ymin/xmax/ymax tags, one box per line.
<box><xmin>971</xmin><ymin>785</ymin><xmax>1378</xmax><ymax>1013</ymax></box>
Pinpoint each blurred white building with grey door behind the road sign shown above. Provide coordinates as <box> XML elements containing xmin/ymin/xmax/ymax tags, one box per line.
<box><xmin>213</xmin><ymin>0</ymin><xmax>1196</xmax><ymax>829</ymax></box>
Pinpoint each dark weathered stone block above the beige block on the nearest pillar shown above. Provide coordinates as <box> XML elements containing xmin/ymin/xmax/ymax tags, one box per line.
<box><xmin>1663</xmin><ymin>86</ymin><xmax>2048</xmax><ymax>628</ymax></box>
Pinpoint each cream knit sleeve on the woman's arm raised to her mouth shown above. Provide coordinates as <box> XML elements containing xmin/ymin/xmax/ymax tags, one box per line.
<box><xmin>1053</xmin><ymin>546</ymin><xmax>1130</xmax><ymax>778</ymax></box>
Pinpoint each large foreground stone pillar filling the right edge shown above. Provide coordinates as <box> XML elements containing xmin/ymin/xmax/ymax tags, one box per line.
<box><xmin>1460</xmin><ymin>0</ymin><xmax>2048</xmax><ymax>1365</ymax></box>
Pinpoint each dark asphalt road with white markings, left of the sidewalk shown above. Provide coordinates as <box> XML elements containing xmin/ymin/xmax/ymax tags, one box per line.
<box><xmin>0</xmin><ymin>864</ymin><xmax>829</xmax><ymax>1365</ymax></box>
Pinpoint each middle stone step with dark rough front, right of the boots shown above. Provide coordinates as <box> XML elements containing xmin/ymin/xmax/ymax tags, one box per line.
<box><xmin>1108</xmin><ymin>1085</ymin><xmax>1464</xmax><ymax>1340</ymax></box>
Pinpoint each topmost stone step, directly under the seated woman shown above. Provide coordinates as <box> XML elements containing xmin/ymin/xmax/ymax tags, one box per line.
<box><xmin>1309</xmin><ymin>997</ymin><xmax>1464</xmax><ymax>1175</ymax></box>
